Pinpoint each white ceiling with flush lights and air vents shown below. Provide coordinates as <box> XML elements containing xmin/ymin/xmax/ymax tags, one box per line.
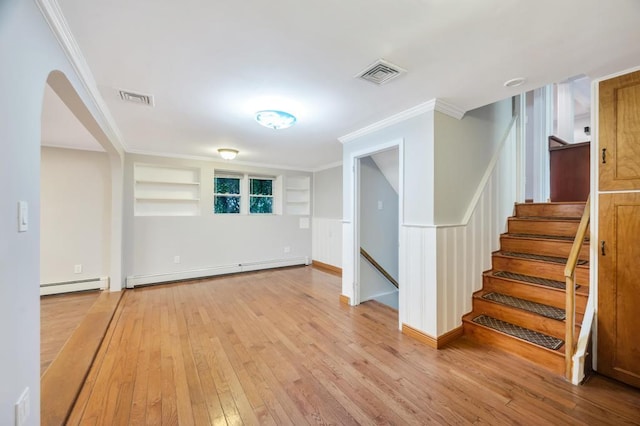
<box><xmin>45</xmin><ymin>0</ymin><xmax>640</xmax><ymax>169</ymax></box>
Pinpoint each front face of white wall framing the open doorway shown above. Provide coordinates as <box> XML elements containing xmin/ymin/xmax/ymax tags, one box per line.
<box><xmin>342</xmin><ymin>110</ymin><xmax>437</xmax><ymax>334</ymax></box>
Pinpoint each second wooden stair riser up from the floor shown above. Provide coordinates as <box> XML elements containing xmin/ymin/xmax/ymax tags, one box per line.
<box><xmin>473</xmin><ymin>292</ymin><xmax>579</xmax><ymax>340</ymax></box>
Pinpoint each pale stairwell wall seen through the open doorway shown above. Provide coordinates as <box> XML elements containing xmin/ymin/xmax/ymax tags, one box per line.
<box><xmin>359</xmin><ymin>157</ymin><xmax>399</xmax><ymax>302</ymax></box>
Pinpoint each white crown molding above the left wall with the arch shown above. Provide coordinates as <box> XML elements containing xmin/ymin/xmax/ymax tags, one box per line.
<box><xmin>34</xmin><ymin>0</ymin><xmax>126</xmax><ymax>153</ymax></box>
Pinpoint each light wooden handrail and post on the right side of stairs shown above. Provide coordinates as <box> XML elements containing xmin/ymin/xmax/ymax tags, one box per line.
<box><xmin>564</xmin><ymin>194</ymin><xmax>591</xmax><ymax>380</ymax></box>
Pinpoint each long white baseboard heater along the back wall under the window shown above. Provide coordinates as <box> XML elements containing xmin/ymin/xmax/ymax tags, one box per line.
<box><xmin>127</xmin><ymin>257</ymin><xmax>310</xmax><ymax>288</ymax></box>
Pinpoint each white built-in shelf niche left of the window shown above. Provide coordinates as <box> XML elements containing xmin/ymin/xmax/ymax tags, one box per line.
<box><xmin>134</xmin><ymin>164</ymin><xmax>200</xmax><ymax>216</ymax></box>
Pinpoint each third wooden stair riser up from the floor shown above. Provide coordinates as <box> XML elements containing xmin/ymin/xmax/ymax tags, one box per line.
<box><xmin>483</xmin><ymin>275</ymin><xmax>587</xmax><ymax>316</ymax></box>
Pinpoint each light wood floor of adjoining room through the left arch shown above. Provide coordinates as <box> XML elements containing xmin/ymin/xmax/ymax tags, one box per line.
<box><xmin>40</xmin><ymin>291</ymin><xmax>100</xmax><ymax>375</ymax></box>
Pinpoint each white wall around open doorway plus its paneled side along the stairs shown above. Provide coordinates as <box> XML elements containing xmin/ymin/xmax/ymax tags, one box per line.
<box><xmin>342</xmin><ymin>99</ymin><xmax>516</xmax><ymax>337</ymax></box>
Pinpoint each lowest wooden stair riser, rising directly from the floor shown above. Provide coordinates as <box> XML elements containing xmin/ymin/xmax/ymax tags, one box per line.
<box><xmin>463</xmin><ymin>319</ymin><xmax>564</xmax><ymax>375</ymax></box>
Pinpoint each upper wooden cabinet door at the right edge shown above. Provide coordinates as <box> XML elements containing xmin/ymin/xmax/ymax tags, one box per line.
<box><xmin>598</xmin><ymin>71</ymin><xmax>640</xmax><ymax>191</ymax></box>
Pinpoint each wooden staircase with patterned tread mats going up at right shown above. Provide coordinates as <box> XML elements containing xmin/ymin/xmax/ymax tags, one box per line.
<box><xmin>463</xmin><ymin>203</ymin><xmax>589</xmax><ymax>374</ymax></box>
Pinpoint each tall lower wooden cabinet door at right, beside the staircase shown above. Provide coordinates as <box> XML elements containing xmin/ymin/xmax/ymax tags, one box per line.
<box><xmin>598</xmin><ymin>192</ymin><xmax>640</xmax><ymax>387</ymax></box>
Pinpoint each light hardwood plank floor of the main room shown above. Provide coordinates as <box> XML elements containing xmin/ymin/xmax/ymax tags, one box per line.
<box><xmin>69</xmin><ymin>267</ymin><xmax>640</xmax><ymax>425</ymax></box>
